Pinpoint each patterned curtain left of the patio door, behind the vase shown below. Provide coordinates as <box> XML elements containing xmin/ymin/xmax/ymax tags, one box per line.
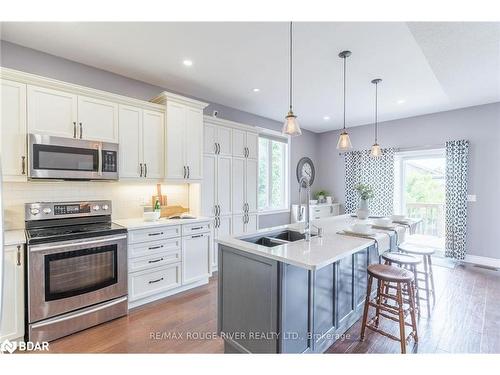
<box><xmin>345</xmin><ymin>148</ymin><xmax>394</xmax><ymax>216</ymax></box>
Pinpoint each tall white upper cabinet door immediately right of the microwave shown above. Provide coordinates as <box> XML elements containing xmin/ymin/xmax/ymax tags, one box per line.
<box><xmin>118</xmin><ymin>105</ymin><xmax>143</xmax><ymax>178</ymax></box>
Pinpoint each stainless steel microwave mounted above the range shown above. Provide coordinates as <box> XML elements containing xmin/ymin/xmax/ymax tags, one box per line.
<box><xmin>28</xmin><ymin>134</ymin><xmax>118</xmax><ymax>180</ymax></box>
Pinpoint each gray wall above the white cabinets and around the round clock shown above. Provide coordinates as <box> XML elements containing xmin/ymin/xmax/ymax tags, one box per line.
<box><xmin>0</xmin><ymin>40</ymin><xmax>317</xmax><ymax>227</ymax></box>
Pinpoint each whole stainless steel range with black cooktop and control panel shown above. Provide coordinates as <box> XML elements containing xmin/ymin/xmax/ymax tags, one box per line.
<box><xmin>25</xmin><ymin>201</ymin><xmax>127</xmax><ymax>341</ymax></box>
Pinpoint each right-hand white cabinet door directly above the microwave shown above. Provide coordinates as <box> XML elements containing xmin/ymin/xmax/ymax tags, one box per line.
<box><xmin>78</xmin><ymin>96</ymin><xmax>118</xmax><ymax>142</ymax></box>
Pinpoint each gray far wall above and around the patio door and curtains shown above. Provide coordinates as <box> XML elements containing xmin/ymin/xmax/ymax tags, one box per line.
<box><xmin>319</xmin><ymin>103</ymin><xmax>500</xmax><ymax>258</ymax></box>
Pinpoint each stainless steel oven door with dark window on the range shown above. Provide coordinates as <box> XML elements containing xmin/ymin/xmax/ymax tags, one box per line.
<box><xmin>28</xmin><ymin>234</ymin><xmax>127</xmax><ymax>323</ymax></box>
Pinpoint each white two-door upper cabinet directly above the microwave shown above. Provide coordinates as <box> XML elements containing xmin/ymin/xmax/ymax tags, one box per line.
<box><xmin>28</xmin><ymin>85</ymin><xmax>118</xmax><ymax>142</ymax></box>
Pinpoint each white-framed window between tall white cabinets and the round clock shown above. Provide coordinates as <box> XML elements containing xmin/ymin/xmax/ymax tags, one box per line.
<box><xmin>258</xmin><ymin>135</ymin><xmax>288</xmax><ymax>211</ymax></box>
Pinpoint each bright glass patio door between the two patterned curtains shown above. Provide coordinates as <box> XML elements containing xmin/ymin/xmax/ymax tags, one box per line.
<box><xmin>394</xmin><ymin>149</ymin><xmax>446</xmax><ymax>250</ymax></box>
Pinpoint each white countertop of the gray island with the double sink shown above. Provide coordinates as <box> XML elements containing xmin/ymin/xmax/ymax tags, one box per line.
<box><xmin>217</xmin><ymin>215</ymin><xmax>407</xmax><ymax>270</ymax></box>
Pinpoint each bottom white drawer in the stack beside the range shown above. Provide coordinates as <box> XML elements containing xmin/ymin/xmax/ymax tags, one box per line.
<box><xmin>128</xmin><ymin>263</ymin><xmax>181</xmax><ymax>301</ymax></box>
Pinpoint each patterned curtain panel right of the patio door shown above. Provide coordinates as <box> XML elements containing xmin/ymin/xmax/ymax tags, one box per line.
<box><xmin>445</xmin><ymin>140</ymin><xmax>469</xmax><ymax>260</ymax></box>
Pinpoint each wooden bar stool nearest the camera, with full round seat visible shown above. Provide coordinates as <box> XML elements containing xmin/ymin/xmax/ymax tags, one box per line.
<box><xmin>361</xmin><ymin>264</ymin><xmax>418</xmax><ymax>353</ymax></box>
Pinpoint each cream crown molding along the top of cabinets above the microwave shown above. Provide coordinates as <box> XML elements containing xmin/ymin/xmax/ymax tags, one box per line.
<box><xmin>0</xmin><ymin>67</ymin><xmax>165</xmax><ymax>112</ymax></box>
